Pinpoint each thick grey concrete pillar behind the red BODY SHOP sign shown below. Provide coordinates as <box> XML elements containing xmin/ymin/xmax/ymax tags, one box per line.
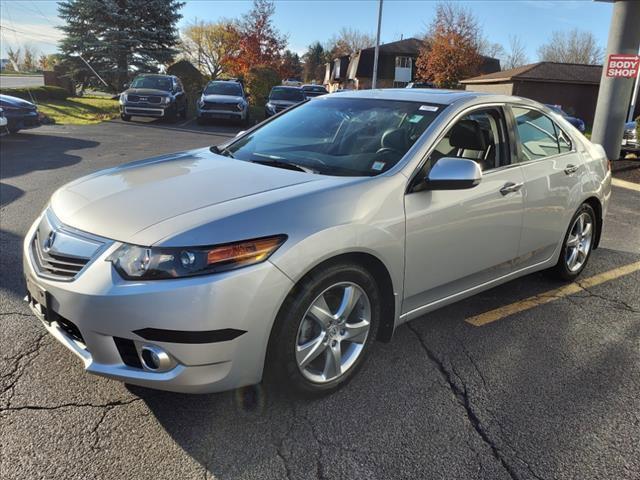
<box><xmin>591</xmin><ymin>0</ymin><xmax>640</xmax><ymax>160</ymax></box>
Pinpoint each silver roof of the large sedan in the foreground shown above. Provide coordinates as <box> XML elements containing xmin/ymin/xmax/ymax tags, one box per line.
<box><xmin>340</xmin><ymin>88</ymin><xmax>490</xmax><ymax>105</ymax></box>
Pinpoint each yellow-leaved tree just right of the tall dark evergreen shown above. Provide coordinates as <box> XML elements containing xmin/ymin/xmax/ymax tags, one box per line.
<box><xmin>181</xmin><ymin>20</ymin><xmax>240</xmax><ymax>79</ymax></box>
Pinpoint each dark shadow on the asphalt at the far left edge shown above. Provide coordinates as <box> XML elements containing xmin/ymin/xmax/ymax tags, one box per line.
<box><xmin>0</xmin><ymin>131</ymin><xmax>99</xmax><ymax>180</ymax></box>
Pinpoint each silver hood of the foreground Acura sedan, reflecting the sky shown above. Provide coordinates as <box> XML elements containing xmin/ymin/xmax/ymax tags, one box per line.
<box><xmin>51</xmin><ymin>149</ymin><xmax>322</xmax><ymax>244</ymax></box>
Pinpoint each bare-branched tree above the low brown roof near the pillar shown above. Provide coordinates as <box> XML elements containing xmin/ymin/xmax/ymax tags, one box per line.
<box><xmin>538</xmin><ymin>28</ymin><xmax>604</xmax><ymax>65</ymax></box>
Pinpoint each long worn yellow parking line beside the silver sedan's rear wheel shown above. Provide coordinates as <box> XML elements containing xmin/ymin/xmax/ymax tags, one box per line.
<box><xmin>465</xmin><ymin>262</ymin><xmax>640</xmax><ymax>327</ymax></box>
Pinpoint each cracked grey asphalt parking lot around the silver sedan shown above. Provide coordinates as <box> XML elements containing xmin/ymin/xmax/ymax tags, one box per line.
<box><xmin>0</xmin><ymin>117</ymin><xmax>640</xmax><ymax>480</ymax></box>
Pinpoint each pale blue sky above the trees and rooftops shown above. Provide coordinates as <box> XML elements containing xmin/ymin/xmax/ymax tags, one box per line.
<box><xmin>0</xmin><ymin>0</ymin><xmax>613</xmax><ymax>62</ymax></box>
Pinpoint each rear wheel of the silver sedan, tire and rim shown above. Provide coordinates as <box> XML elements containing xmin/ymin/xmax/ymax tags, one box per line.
<box><xmin>549</xmin><ymin>203</ymin><xmax>598</xmax><ymax>281</ymax></box>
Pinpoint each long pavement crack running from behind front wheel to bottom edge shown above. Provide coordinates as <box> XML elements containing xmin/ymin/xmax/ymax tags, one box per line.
<box><xmin>407</xmin><ymin>323</ymin><xmax>542</xmax><ymax>480</ymax></box>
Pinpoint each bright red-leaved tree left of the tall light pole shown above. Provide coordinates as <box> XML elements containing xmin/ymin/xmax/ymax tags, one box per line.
<box><xmin>232</xmin><ymin>0</ymin><xmax>287</xmax><ymax>77</ymax></box>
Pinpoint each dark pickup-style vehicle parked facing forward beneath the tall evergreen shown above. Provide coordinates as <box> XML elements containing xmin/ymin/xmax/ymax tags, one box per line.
<box><xmin>120</xmin><ymin>74</ymin><xmax>188</xmax><ymax>122</ymax></box>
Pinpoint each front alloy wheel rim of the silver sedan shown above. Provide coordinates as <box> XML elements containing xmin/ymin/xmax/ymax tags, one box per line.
<box><xmin>295</xmin><ymin>282</ymin><xmax>371</xmax><ymax>383</ymax></box>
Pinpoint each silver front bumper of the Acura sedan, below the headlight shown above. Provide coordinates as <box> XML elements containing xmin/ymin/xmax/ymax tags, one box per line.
<box><xmin>23</xmin><ymin>215</ymin><xmax>292</xmax><ymax>393</ymax></box>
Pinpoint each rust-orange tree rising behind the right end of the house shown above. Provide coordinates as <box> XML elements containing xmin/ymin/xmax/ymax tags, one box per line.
<box><xmin>416</xmin><ymin>3</ymin><xmax>482</xmax><ymax>88</ymax></box>
